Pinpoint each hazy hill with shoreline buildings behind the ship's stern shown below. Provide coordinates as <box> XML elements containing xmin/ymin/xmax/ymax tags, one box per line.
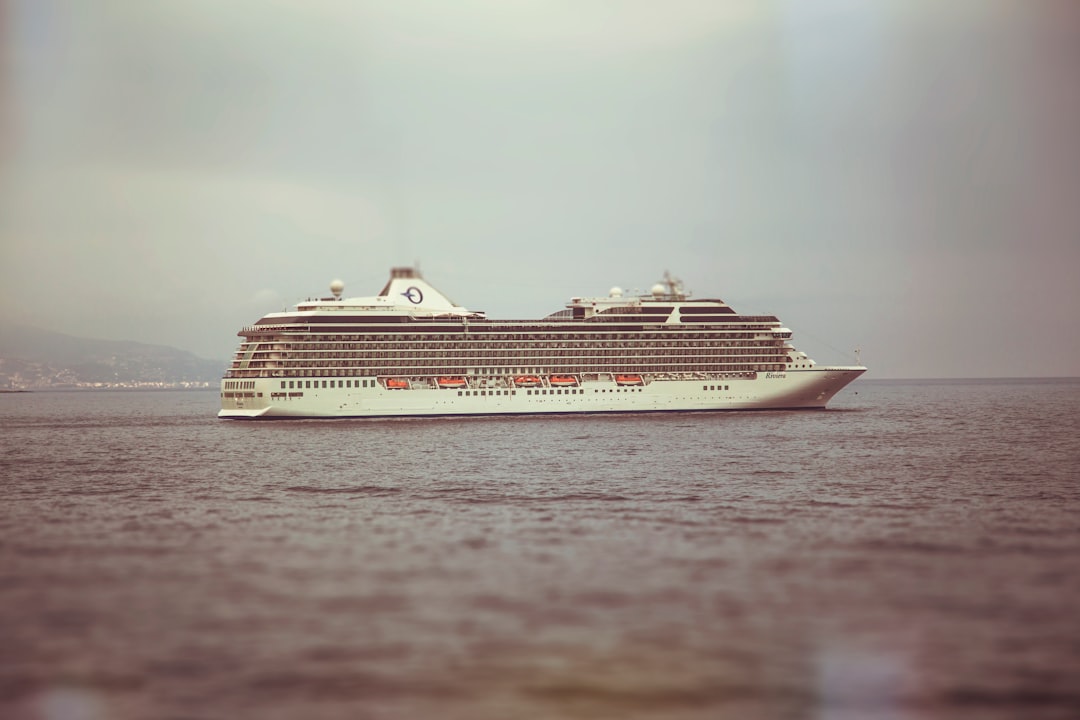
<box><xmin>0</xmin><ymin>324</ymin><xmax>225</xmax><ymax>390</ymax></box>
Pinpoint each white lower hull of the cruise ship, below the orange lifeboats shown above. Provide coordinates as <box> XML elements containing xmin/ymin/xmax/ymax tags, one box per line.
<box><xmin>218</xmin><ymin>367</ymin><xmax>866</xmax><ymax>420</ymax></box>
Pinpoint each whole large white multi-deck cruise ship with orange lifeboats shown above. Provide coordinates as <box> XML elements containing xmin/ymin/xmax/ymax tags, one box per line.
<box><xmin>218</xmin><ymin>268</ymin><xmax>866</xmax><ymax>419</ymax></box>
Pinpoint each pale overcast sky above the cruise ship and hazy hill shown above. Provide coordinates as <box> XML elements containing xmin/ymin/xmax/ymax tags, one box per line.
<box><xmin>0</xmin><ymin>0</ymin><xmax>1080</xmax><ymax>378</ymax></box>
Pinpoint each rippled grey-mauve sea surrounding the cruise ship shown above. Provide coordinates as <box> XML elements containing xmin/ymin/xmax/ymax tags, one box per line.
<box><xmin>0</xmin><ymin>378</ymin><xmax>1080</xmax><ymax>720</ymax></box>
